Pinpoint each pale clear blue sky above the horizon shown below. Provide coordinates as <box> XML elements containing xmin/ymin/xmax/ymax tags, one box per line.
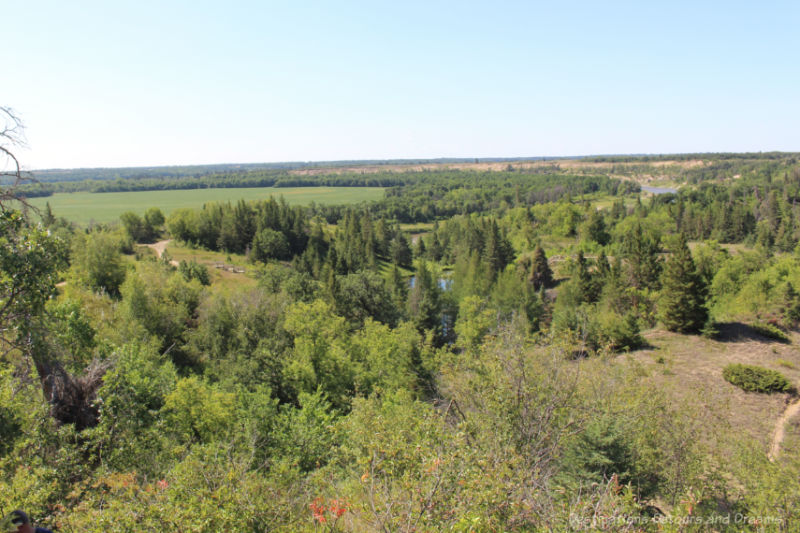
<box><xmin>6</xmin><ymin>0</ymin><xmax>800</xmax><ymax>168</ymax></box>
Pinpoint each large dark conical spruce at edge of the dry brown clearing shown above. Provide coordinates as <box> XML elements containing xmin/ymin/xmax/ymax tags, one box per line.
<box><xmin>658</xmin><ymin>233</ymin><xmax>708</xmax><ymax>333</ymax></box>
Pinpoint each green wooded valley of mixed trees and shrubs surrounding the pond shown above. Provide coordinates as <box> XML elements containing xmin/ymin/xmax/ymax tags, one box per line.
<box><xmin>0</xmin><ymin>147</ymin><xmax>800</xmax><ymax>533</ymax></box>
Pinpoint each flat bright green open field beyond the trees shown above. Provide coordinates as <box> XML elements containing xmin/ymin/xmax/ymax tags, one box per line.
<box><xmin>31</xmin><ymin>187</ymin><xmax>383</xmax><ymax>224</ymax></box>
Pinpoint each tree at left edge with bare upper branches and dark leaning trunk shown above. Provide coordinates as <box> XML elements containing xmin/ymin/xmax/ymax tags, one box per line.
<box><xmin>0</xmin><ymin>107</ymin><xmax>108</xmax><ymax>430</ymax></box>
